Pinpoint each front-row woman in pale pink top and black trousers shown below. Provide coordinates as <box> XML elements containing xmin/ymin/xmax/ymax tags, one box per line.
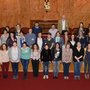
<box><xmin>31</xmin><ymin>44</ymin><xmax>40</xmax><ymax>77</ymax></box>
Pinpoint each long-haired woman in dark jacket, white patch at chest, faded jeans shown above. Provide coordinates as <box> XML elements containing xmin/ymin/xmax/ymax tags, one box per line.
<box><xmin>53</xmin><ymin>43</ymin><xmax>62</xmax><ymax>79</ymax></box>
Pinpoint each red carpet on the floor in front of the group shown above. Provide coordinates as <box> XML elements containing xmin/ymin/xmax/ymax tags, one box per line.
<box><xmin>0</xmin><ymin>73</ymin><xmax>90</xmax><ymax>90</ymax></box>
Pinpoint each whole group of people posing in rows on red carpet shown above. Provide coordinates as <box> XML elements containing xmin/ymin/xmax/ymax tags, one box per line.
<box><xmin>0</xmin><ymin>16</ymin><xmax>90</xmax><ymax>80</ymax></box>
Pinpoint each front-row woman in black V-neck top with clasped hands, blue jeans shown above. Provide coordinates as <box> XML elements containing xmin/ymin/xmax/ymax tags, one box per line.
<box><xmin>73</xmin><ymin>42</ymin><xmax>84</xmax><ymax>80</ymax></box>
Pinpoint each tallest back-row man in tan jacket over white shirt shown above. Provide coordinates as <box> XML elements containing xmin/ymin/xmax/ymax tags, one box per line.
<box><xmin>58</xmin><ymin>15</ymin><xmax>69</xmax><ymax>34</ymax></box>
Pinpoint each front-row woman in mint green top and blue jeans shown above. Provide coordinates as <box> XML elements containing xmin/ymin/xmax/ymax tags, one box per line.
<box><xmin>21</xmin><ymin>42</ymin><xmax>31</xmax><ymax>80</ymax></box>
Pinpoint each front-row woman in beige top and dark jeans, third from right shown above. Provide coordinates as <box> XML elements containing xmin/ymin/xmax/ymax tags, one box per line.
<box><xmin>62</xmin><ymin>43</ymin><xmax>73</xmax><ymax>79</ymax></box>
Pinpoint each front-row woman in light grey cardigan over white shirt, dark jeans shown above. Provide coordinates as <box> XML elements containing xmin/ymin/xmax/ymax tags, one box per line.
<box><xmin>9</xmin><ymin>41</ymin><xmax>20</xmax><ymax>79</ymax></box>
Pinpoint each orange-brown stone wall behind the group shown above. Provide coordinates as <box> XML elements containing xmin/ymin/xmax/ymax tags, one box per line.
<box><xmin>0</xmin><ymin>0</ymin><xmax>90</xmax><ymax>27</ymax></box>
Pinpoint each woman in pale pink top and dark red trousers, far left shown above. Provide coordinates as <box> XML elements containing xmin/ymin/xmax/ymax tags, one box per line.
<box><xmin>0</xmin><ymin>43</ymin><xmax>9</xmax><ymax>78</ymax></box>
